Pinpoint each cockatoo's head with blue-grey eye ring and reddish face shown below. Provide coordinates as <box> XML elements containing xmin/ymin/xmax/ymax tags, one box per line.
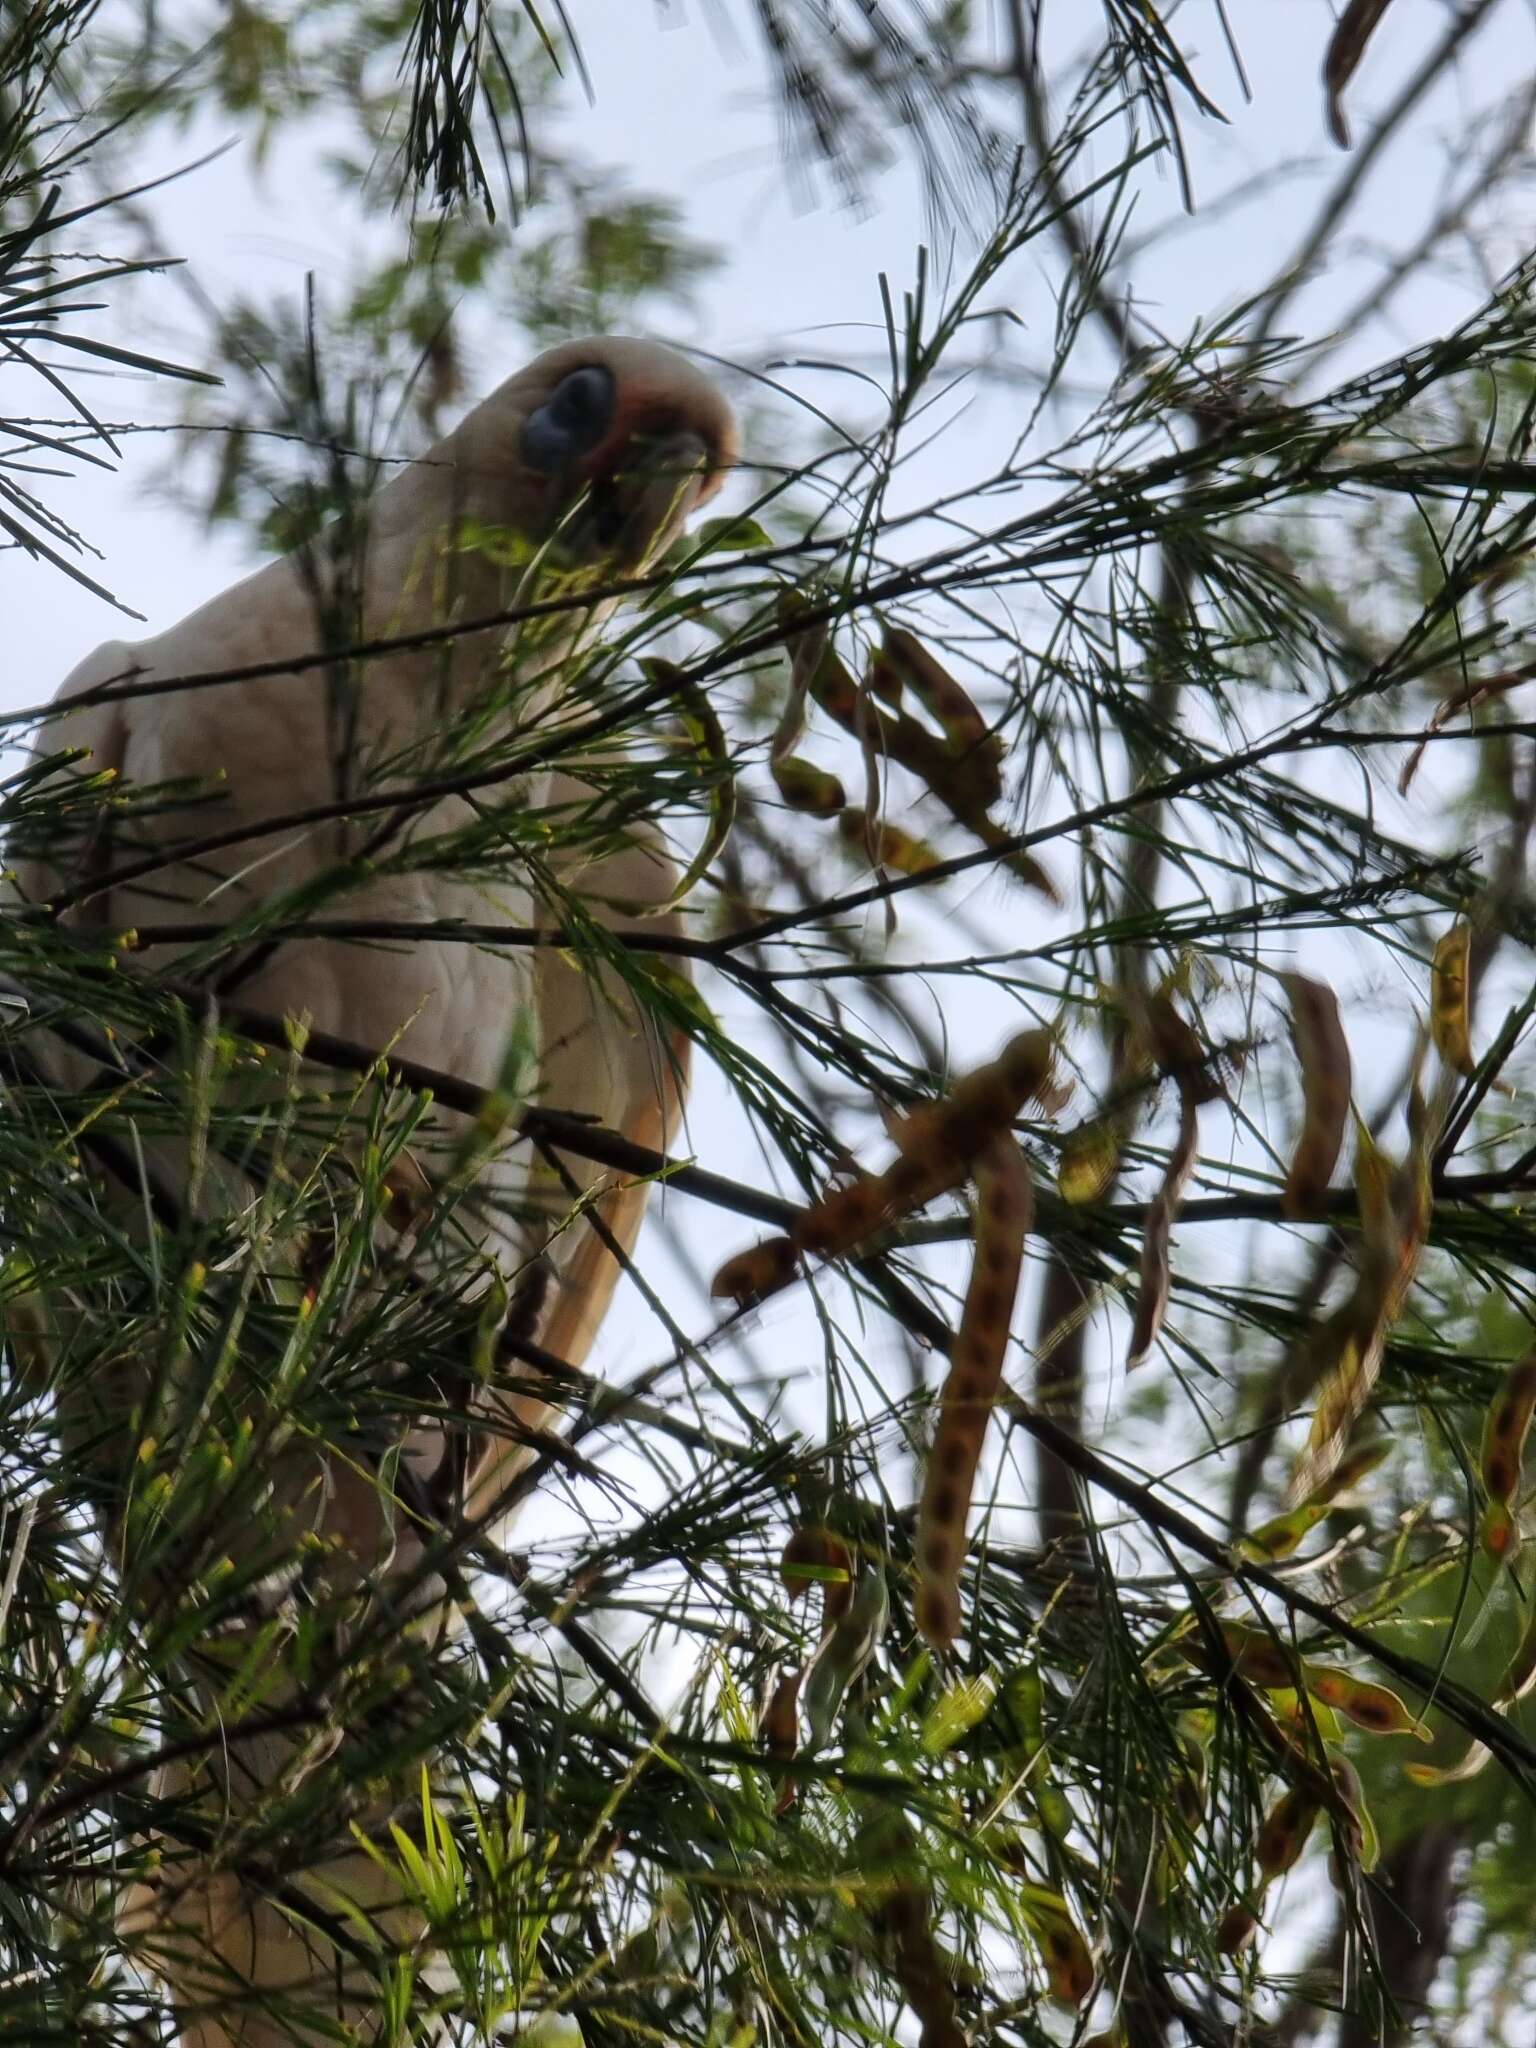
<box><xmin>489</xmin><ymin>336</ymin><xmax>739</xmax><ymax>571</ymax></box>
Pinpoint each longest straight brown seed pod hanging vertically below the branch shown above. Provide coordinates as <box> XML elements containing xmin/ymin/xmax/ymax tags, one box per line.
<box><xmin>915</xmin><ymin>1139</ymin><xmax>1034</xmax><ymax>1649</ymax></box>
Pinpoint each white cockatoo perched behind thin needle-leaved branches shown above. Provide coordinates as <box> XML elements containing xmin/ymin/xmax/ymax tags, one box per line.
<box><xmin>14</xmin><ymin>338</ymin><xmax>737</xmax><ymax>2048</ymax></box>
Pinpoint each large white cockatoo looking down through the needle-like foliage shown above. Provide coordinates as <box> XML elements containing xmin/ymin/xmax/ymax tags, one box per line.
<box><xmin>14</xmin><ymin>338</ymin><xmax>737</xmax><ymax>2048</ymax></box>
